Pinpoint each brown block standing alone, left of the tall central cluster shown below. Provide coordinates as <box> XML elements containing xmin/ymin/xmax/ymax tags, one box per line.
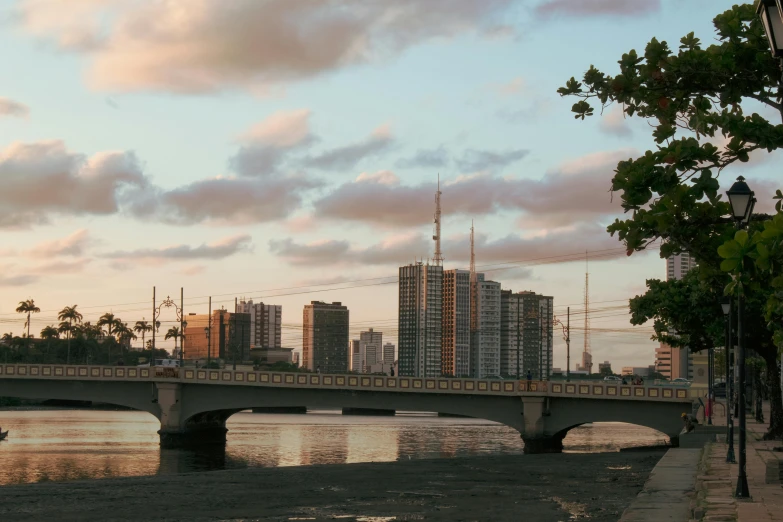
<box><xmin>302</xmin><ymin>301</ymin><xmax>349</xmax><ymax>373</ymax></box>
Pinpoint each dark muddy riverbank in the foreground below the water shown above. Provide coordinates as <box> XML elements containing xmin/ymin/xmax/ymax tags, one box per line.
<box><xmin>0</xmin><ymin>451</ymin><xmax>664</xmax><ymax>522</ymax></box>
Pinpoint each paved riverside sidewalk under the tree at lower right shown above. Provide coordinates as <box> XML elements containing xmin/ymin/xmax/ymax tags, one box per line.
<box><xmin>693</xmin><ymin>400</ymin><xmax>783</xmax><ymax>522</ymax></box>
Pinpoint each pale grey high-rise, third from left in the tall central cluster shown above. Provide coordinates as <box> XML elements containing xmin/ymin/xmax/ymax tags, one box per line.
<box><xmin>471</xmin><ymin>274</ymin><xmax>501</xmax><ymax>379</ymax></box>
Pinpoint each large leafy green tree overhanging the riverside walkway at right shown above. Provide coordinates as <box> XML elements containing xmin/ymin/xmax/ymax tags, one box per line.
<box><xmin>558</xmin><ymin>4</ymin><xmax>783</xmax><ymax>437</ymax></box>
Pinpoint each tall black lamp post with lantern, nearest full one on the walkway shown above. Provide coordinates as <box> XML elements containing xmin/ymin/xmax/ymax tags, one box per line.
<box><xmin>726</xmin><ymin>177</ymin><xmax>756</xmax><ymax>498</ymax></box>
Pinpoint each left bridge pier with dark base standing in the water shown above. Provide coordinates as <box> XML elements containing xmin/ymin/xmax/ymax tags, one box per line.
<box><xmin>155</xmin><ymin>383</ymin><xmax>234</xmax><ymax>448</ymax></box>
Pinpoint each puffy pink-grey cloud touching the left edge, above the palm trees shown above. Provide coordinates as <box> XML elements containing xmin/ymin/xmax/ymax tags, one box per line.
<box><xmin>0</xmin><ymin>141</ymin><xmax>147</xmax><ymax>228</ymax></box>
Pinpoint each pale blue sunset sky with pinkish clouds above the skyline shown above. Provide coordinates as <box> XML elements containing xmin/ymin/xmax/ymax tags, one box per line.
<box><xmin>0</xmin><ymin>0</ymin><xmax>779</xmax><ymax>370</ymax></box>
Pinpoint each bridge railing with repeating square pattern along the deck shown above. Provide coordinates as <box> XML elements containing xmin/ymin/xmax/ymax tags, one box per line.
<box><xmin>0</xmin><ymin>364</ymin><xmax>696</xmax><ymax>402</ymax></box>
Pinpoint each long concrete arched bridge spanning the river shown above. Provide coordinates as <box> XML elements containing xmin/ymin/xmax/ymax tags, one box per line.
<box><xmin>0</xmin><ymin>364</ymin><xmax>692</xmax><ymax>453</ymax></box>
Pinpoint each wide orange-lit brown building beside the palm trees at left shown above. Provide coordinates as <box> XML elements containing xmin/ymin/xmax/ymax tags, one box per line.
<box><xmin>184</xmin><ymin>310</ymin><xmax>250</xmax><ymax>362</ymax></box>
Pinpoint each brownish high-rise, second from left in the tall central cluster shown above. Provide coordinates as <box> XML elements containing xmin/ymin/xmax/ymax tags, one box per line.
<box><xmin>441</xmin><ymin>270</ymin><xmax>484</xmax><ymax>377</ymax></box>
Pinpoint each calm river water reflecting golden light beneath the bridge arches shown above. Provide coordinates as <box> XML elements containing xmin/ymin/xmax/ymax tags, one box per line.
<box><xmin>0</xmin><ymin>409</ymin><xmax>665</xmax><ymax>485</ymax></box>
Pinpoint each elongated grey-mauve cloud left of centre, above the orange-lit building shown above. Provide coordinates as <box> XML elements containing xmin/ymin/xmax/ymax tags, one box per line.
<box><xmin>131</xmin><ymin>176</ymin><xmax>321</xmax><ymax>225</ymax></box>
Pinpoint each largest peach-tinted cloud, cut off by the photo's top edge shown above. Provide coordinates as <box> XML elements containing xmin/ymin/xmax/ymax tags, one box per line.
<box><xmin>18</xmin><ymin>0</ymin><xmax>515</xmax><ymax>93</ymax></box>
